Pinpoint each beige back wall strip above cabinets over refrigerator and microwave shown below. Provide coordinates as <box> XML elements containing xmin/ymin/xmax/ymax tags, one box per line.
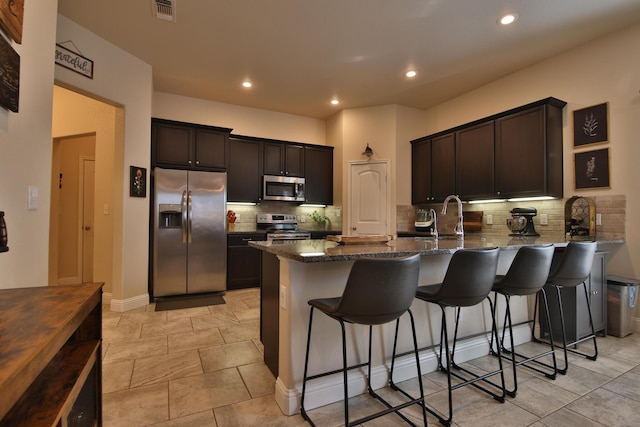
<box><xmin>153</xmin><ymin>92</ymin><xmax>326</xmax><ymax>145</ymax></box>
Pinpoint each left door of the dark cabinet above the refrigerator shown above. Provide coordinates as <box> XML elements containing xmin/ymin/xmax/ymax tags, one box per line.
<box><xmin>151</xmin><ymin>122</ymin><xmax>193</xmax><ymax>168</ymax></box>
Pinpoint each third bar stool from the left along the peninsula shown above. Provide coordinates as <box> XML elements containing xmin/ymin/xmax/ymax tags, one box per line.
<box><xmin>491</xmin><ymin>245</ymin><xmax>558</xmax><ymax>397</ymax></box>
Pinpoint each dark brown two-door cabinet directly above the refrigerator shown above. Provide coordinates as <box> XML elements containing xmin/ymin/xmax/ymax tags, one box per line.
<box><xmin>151</xmin><ymin>119</ymin><xmax>231</xmax><ymax>170</ymax></box>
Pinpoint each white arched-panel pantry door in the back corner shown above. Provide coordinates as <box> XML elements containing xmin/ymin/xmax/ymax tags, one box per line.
<box><xmin>349</xmin><ymin>161</ymin><xmax>391</xmax><ymax>236</ymax></box>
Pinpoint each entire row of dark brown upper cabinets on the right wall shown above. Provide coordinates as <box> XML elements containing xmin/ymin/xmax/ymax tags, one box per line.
<box><xmin>411</xmin><ymin>98</ymin><xmax>566</xmax><ymax>204</ymax></box>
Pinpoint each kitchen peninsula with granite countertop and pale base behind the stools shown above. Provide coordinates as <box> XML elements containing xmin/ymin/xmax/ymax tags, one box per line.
<box><xmin>249</xmin><ymin>235</ymin><xmax>619</xmax><ymax>415</ymax></box>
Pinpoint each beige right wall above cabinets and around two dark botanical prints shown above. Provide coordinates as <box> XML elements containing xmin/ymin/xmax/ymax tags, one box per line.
<box><xmin>418</xmin><ymin>25</ymin><xmax>640</xmax><ymax>278</ymax></box>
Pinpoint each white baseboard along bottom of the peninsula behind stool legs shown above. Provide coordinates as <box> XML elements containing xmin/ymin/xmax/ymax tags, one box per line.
<box><xmin>275</xmin><ymin>325</ymin><xmax>531</xmax><ymax>415</ymax></box>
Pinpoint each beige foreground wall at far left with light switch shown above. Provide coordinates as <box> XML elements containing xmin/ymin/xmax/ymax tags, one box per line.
<box><xmin>0</xmin><ymin>1</ymin><xmax>58</xmax><ymax>289</ymax></box>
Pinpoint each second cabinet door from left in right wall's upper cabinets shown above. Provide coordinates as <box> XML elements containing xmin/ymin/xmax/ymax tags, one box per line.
<box><xmin>430</xmin><ymin>134</ymin><xmax>456</xmax><ymax>202</ymax></box>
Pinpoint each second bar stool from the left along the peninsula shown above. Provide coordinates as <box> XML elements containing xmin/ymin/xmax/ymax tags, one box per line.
<box><xmin>391</xmin><ymin>248</ymin><xmax>505</xmax><ymax>426</ymax></box>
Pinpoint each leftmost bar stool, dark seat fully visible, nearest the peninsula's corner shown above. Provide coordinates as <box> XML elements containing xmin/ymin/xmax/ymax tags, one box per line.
<box><xmin>300</xmin><ymin>254</ymin><xmax>427</xmax><ymax>426</ymax></box>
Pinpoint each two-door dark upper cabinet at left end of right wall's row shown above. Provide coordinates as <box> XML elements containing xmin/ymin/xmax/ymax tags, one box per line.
<box><xmin>411</xmin><ymin>133</ymin><xmax>455</xmax><ymax>205</ymax></box>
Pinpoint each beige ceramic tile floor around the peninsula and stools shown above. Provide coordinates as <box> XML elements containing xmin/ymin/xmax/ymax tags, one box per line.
<box><xmin>103</xmin><ymin>289</ymin><xmax>640</xmax><ymax>427</ymax></box>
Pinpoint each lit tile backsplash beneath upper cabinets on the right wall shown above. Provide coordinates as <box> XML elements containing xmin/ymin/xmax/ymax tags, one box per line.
<box><xmin>396</xmin><ymin>195</ymin><xmax>626</xmax><ymax>240</ymax></box>
